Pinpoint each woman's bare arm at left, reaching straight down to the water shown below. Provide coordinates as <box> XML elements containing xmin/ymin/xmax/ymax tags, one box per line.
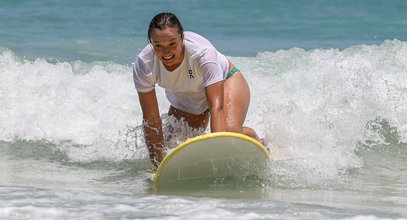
<box><xmin>138</xmin><ymin>89</ymin><xmax>164</xmax><ymax>167</ymax></box>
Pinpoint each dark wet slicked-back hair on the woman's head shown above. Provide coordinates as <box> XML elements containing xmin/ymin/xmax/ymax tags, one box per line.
<box><xmin>148</xmin><ymin>12</ymin><xmax>184</xmax><ymax>42</ymax></box>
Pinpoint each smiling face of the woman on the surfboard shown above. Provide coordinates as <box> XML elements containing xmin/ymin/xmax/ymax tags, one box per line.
<box><xmin>150</xmin><ymin>27</ymin><xmax>184</xmax><ymax>71</ymax></box>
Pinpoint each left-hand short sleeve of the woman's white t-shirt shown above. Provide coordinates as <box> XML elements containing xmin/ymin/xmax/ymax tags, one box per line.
<box><xmin>133</xmin><ymin>57</ymin><xmax>155</xmax><ymax>92</ymax></box>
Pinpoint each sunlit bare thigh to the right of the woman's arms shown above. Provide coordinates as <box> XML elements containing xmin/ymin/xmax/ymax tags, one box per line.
<box><xmin>224</xmin><ymin>71</ymin><xmax>250</xmax><ymax>129</ymax></box>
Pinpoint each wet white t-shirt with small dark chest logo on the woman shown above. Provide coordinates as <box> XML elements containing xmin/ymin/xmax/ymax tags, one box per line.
<box><xmin>133</xmin><ymin>32</ymin><xmax>229</xmax><ymax>115</ymax></box>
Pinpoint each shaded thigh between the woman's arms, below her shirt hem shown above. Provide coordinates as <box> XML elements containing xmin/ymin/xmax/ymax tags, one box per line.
<box><xmin>168</xmin><ymin>105</ymin><xmax>209</xmax><ymax>129</ymax></box>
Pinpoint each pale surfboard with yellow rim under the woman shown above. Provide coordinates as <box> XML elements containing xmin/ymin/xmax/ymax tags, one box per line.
<box><xmin>150</xmin><ymin>132</ymin><xmax>271</xmax><ymax>184</ymax></box>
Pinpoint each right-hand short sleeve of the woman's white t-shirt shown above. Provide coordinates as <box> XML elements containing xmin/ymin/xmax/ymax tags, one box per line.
<box><xmin>198</xmin><ymin>48</ymin><xmax>224</xmax><ymax>87</ymax></box>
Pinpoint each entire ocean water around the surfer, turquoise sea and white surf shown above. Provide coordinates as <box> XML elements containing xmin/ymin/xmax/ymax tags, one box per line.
<box><xmin>0</xmin><ymin>0</ymin><xmax>407</xmax><ymax>220</ymax></box>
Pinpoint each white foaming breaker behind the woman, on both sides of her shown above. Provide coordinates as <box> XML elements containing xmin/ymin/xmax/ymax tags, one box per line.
<box><xmin>0</xmin><ymin>40</ymin><xmax>407</xmax><ymax>184</ymax></box>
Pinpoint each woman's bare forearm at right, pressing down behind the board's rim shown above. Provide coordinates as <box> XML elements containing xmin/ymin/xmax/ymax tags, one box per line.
<box><xmin>205</xmin><ymin>81</ymin><xmax>226</xmax><ymax>133</ymax></box>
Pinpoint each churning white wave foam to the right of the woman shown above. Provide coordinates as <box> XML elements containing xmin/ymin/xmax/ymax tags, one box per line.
<box><xmin>235</xmin><ymin>40</ymin><xmax>407</xmax><ymax>185</ymax></box>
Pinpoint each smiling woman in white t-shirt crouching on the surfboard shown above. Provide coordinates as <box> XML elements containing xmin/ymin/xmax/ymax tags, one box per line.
<box><xmin>133</xmin><ymin>13</ymin><xmax>260</xmax><ymax>166</ymax></box>
